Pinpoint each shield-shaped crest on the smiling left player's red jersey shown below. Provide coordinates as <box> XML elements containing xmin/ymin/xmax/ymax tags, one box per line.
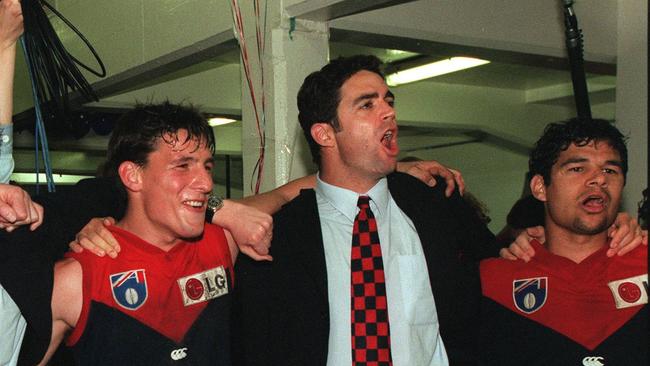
<box><xmin>109</xmin><ymin>269</ymin><xmax>148</xmax><ymax>310</ymax></box>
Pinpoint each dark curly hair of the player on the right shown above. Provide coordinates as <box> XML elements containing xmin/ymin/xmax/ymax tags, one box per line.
<box><xmin>528</xmin><ymin>118</ymin><xmax>627</xmax><ymax>186</ymax></box>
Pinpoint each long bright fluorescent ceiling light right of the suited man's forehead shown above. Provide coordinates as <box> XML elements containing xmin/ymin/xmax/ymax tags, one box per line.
<box><xmin>386</xmin><ymin>57</ymin><xmax>490</xmax><ymax>86</ymax></box>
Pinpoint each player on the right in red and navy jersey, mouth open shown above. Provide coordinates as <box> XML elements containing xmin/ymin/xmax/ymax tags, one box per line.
<box><xmin>480</xmin><ymin>119</ymin><xmax>649</xmax><ymax>366</ymax></box>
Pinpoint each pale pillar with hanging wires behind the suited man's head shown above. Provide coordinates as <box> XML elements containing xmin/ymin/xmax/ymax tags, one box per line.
<box><xmin>242</xmin><ymin>1</ymin><xmax>329</xmax><ymax>195</ymax></box>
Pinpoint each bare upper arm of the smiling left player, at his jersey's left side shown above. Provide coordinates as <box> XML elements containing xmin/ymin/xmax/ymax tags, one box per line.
<box><xmin>39</xmin><ymin>258</ymin><xmax>83</xmax><ymax>365</ymax></box>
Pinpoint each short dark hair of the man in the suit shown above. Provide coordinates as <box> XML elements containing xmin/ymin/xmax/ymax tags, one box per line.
<box><xmin>298</xmin><ymin>55</ymin><xmax>384</xmax><ymax>165</ymax></box>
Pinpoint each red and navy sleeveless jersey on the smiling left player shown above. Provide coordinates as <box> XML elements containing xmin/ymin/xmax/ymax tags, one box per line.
<box><xmin>67</xmin><ymin>225</ymin><xmax>232</xmax><ymax>365</ymax></box>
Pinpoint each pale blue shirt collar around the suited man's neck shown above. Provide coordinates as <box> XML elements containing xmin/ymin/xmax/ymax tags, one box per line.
<box><xmin>315</xmin><ymin>174</ymin><xmax>389</xmax><ymax>221</ymax></box>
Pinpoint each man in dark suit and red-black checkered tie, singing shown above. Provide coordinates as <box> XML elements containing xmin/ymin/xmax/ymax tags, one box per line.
<box><xmin>233</xmin><ymin>56</ymin><xmax>498</xmax><ymax>365</ymax></box>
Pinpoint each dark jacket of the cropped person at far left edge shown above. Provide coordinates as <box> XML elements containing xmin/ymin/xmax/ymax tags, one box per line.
<box><xmin>0</xmin><ymin>178</ymin><xmax>125</xmax><ymax>365</ymax></box>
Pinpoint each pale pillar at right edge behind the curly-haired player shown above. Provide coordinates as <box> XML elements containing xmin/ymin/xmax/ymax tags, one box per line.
<box><xmin>616</xmin><ymin>0</ymin><xmax>648</xmax><ymax>216</ymax></box>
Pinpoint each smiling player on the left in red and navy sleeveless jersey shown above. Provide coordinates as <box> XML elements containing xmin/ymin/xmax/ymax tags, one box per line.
<box><xmin>36</xmin><ymin>102</ymin><xmax>268</xmax><ymax>366</ymax></box>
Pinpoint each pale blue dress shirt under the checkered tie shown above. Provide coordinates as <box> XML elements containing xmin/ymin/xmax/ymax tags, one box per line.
<box><xmin>315</xmin><ymin>177</ymin><xmax>449</xmax><ymax>366</ymax></box>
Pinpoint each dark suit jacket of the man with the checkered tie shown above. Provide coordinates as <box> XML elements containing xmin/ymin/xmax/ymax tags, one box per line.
<box><xmin>232</xmin><ymin>173</ymin><xmax>498</xmax><ymax>366</ymax></box>
